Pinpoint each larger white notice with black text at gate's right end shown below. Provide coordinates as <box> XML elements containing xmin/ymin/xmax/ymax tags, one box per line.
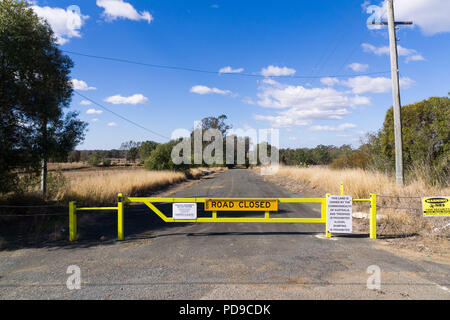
<box><xmin>327</xmin><ymin>196</ymin><xmax>353</xmax><ymax>233</ymax></box>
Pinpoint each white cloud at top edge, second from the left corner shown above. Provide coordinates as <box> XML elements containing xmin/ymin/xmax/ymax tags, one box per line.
<box><xmin>97</xmin><ymin>0</ymin><xmax>153</xmax><ymax>23</ymax></box>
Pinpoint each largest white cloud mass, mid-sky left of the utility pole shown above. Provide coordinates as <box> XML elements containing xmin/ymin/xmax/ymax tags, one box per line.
<box><xmin>254</xmin><ymin>80</ymin><xmax>370</xmax><ymax>128</ymax></box>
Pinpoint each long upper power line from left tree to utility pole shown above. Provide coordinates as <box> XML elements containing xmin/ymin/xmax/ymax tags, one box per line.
<box><xmin>62</xmin><ymin>50</ymin><xmax>391</xmax><ymax>79</ymax></box>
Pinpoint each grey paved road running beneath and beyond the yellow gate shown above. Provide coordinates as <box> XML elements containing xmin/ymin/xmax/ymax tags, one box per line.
<box><xmin>0</xmin><ymin>170</ymin><xmax>450</xmax><ymax>299</ymax></box>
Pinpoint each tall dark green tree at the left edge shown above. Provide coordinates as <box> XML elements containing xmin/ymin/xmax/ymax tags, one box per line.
<box><xmin>0</xmin><ymin>0</ymin><xmax>87</xmax><ymax>198</ymax></box>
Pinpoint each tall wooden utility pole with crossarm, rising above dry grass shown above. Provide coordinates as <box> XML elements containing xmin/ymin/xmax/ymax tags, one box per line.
<box><xmin>369</xmin><ymin>0</ymin><xmax>412</xmax><ymax>185</ymax></box>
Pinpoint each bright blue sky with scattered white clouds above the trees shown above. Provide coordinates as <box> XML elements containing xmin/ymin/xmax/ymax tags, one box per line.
<box><xmin>32</xmin><ymin>0</ymin><xmax>450</xmax><ymax>149</ymax></box>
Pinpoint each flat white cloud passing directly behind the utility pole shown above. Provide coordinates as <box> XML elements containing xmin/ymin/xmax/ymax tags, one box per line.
<box><xmin>340</xmin><ymin>76</ymin><xmax>415</xmax><ymax>94</ymax></box>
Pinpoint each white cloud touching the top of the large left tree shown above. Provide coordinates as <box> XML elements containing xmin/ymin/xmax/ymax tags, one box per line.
<box><xmin>31</xmin><ymin>2</ymin><xmax>89</xmax><ymax>45</ymax></box>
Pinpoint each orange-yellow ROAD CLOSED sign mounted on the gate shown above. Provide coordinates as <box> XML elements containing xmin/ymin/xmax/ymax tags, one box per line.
<box><xmin>205</xmin><ymin>199</ymin><xmax>278</xmax><ymax>211</ymax></box>
